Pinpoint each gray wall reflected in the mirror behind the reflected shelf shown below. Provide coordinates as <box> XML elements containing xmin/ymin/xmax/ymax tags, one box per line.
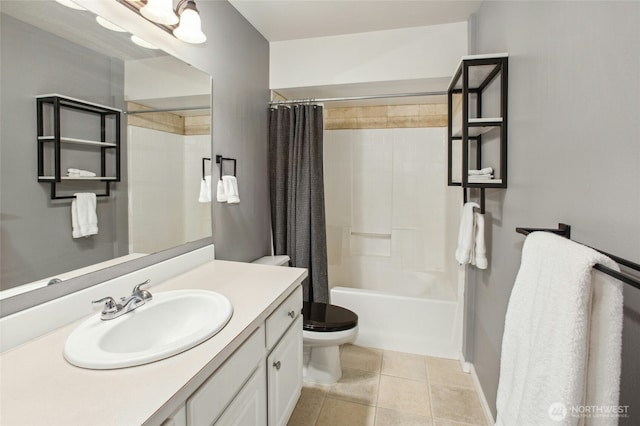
<box><xmin>0</xmin><ymin>14</ymin><xmax>128</xmax><ymax>289</ymax></box>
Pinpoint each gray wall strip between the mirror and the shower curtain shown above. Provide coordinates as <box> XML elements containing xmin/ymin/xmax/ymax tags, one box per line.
<box><xmin>169</xmin><ymin>1</ymin><xmax>271</xmax><ymax>261</ymax></box>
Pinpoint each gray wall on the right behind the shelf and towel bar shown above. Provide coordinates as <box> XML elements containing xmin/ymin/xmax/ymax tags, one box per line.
<box><xmin>467</xmin><ymin>2</ymin><xmax>640</xmax><ymax>424</ymax></box>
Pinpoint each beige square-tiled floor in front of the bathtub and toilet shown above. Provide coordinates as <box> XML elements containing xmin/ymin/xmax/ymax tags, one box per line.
<box><xmin>289</xmin><ymin>345</ymin><xmax>486</xmax><ymax>426</ymax></box>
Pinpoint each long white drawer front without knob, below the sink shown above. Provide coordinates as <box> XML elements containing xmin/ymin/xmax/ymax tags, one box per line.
<box><xmin>187</xmin><ymin>327</ymin><xmax>265</xmax><ymax>425</ymax></box>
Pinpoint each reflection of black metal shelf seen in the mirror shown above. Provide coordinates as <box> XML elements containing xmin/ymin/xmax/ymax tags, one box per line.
<box><xmin>36</xmin><ymin>94</ymin><xmax>122</xmax><ymax>199</ymax></box>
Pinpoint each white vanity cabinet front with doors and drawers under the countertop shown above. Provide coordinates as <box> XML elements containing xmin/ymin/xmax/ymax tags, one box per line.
<box><xmin>180</xmin><ymin>287</ymin><xmax>302</xmax><ymax>426</ymax></box>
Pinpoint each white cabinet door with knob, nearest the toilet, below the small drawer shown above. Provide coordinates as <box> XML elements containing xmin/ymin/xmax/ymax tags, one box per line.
<box><xmin>267</xmin><ymin>315</ymin><xmax>302</xmax><ymax>426</ymax></box>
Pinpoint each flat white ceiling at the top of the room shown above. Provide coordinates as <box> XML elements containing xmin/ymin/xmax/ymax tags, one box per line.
<box><xmin>229</xmin><ymin>0</ymin><xmax>482</xmax><ymax>42</ymax></box>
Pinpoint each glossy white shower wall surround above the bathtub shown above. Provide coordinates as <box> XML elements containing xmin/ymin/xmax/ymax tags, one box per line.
<box><xmin>324</xmin><ymin>128</ymin><xmax>460</xmax><ymax>300</ymax></box>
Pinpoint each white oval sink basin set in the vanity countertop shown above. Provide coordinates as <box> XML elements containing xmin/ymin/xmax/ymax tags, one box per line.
<box><xmin>64</xmin><ymin>290</ymin><xmax>233</xmax><ymax>370</ymax></box>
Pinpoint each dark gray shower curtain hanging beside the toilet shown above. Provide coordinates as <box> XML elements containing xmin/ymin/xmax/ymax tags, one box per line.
<box><xmin>269</xmin><ymin>105</ymin><xmax>329</xmax><ymax>303</ymax></box>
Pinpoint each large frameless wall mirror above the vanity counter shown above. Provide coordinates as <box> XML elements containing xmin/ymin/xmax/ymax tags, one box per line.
<box><xmin>0</xmin><ymin>0</ymin><xmax>212</xmax><ymax>315</ymax></box>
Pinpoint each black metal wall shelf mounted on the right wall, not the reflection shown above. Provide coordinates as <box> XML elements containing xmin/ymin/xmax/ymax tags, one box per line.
<box><xmin>447</xmin><ymin>53</ymin><xmax>509</xmax><ymax>213</ymax></box>
